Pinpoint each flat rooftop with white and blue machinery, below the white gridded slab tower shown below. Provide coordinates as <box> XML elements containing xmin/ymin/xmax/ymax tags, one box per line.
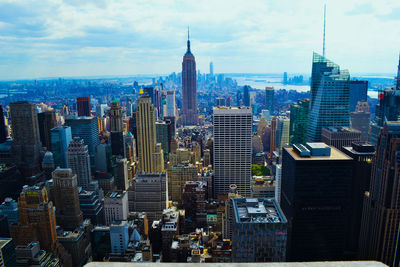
<box><xmin>233</xmin><ymin>198</ymin><xmax>287</xmax><ymax>224</ymax></box>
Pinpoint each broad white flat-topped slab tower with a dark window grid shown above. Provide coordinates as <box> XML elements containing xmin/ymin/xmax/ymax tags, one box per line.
<box><xmin>213</xmin><ymin>107</ymin><xmax>252</xmax><ymax>196</ymax></box>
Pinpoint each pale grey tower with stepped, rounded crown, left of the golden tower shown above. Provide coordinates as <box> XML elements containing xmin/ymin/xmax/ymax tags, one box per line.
<box><xmin>67</xmin><ymin>137</ymin><xmax>92</xmax><ymax>189</ymax></box>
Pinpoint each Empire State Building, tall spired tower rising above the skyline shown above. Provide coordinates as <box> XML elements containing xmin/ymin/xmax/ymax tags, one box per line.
<box><xmin>182</xmin><ymin>31</ymin><xmax>199</xmax><ymax>125</ymax></box>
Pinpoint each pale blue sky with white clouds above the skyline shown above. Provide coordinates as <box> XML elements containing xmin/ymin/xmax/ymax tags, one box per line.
<box><xmin>0</xmin><ymin>0</ymin><xmax>400</xmax><ymax>80</ymax></box>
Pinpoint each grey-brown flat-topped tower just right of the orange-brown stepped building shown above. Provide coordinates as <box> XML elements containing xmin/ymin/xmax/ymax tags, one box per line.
<box><xmin>53</xmin><ymin>168</ymin><xmax>83</xmax><ymax>231</ymax></box>
